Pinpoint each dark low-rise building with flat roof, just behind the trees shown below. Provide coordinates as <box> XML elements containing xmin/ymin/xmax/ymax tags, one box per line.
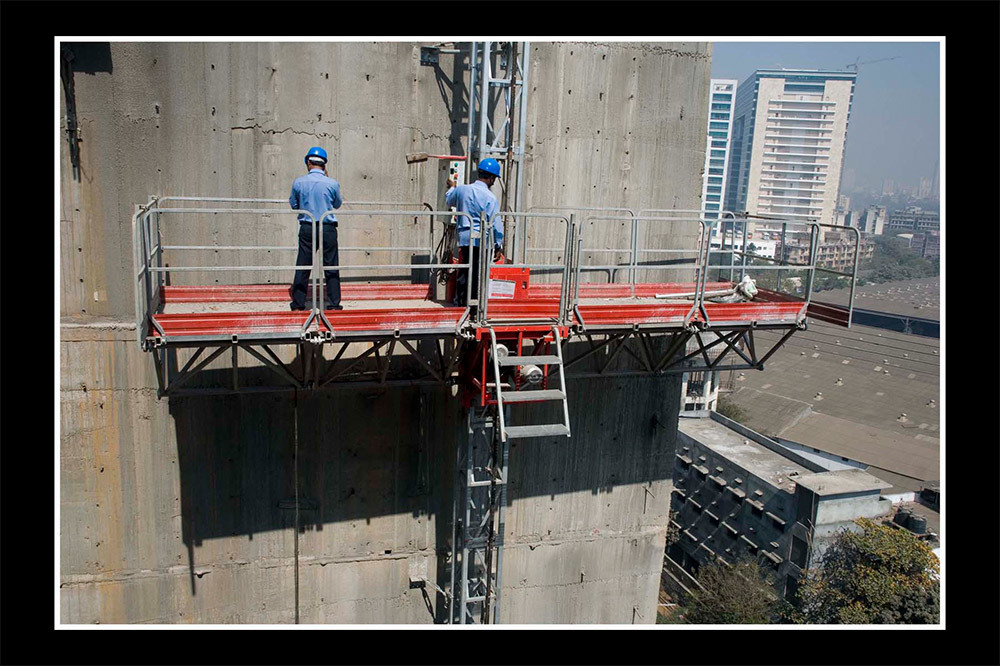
<box><xmin>667</xmin><ymin>412</ymin><xmax>892</xmax><ymax>598</ymax></box>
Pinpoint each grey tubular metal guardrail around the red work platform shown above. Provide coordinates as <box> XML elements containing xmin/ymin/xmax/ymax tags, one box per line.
<box><xmin>132</xmin><ymin>197</ymin><xmax>861</xmax><ymax>344</ymax></box>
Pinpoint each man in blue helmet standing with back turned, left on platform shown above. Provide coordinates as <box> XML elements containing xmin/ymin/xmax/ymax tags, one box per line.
<box><xmin>288</xmin><ymin>146</ymin><xmax>344</xmax><ymax>310</ymax></box>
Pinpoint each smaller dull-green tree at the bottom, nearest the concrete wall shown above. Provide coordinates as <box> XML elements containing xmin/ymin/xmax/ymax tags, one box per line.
<box><xmin>684</xmin><ymin>558</ymin><xmax>784</xmax><ymax>624</ymax></box>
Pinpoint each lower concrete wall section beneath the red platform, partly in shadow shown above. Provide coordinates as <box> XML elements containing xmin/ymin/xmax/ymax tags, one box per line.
<box><xmin>60</xmin><ymin>325</ymin><xmax>679</xmax><ymax>623</ymax></box>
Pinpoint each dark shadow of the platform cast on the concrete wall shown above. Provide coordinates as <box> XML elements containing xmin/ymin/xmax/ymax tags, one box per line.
<box><xmin>169</xmin><ymin>338</ymin><xmax>678</xmax><ymax>622</ymax></box>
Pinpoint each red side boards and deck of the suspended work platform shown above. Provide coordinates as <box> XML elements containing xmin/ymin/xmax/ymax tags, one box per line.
<box><xmin>150</xmin><ymin>282</ymin><xmax>804</xmax><ymax>341</ymax></box>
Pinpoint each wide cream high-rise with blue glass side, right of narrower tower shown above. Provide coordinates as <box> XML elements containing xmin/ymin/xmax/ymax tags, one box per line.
<box><xmin>725</xmin><ymin>69</ymin><xmax>857</xmax><ymax>223</ymax></box>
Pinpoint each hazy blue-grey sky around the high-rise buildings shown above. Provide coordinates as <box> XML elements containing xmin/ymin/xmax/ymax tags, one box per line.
<box><xmin>712</xmin><ymin>42</ymin><xmax>936</xmax><ymax>187</ymax></box>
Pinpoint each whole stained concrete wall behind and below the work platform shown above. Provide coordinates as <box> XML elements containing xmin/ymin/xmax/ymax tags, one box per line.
<box><xmin>60</xmin><ymin>43</ymin><xmax>710</xmax><ymax>623</ymax></box>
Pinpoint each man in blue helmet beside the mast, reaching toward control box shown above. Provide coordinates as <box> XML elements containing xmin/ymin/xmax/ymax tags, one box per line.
<box><xmin>444</xmin><ymin>158</ymin><xmax>503</xmax><ymax>305</ymax></box>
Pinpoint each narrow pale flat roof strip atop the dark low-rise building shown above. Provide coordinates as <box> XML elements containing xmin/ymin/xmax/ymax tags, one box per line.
<box><xmin>677</xmin><ymin>417</ymin><xmax>812</xmax><ymax>493</ymax></box>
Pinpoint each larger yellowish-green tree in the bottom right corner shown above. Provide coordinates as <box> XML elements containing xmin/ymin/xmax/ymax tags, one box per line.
<box><xmin>797</xmin><ymin>518</ymin><xmax>940</xmax><ymax>624</ymax></box>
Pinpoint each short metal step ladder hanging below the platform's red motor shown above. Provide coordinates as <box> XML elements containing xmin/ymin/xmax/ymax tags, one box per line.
<box><xmin>490</xmin><ymin>326</ymin><xmax>570</xmax><ymax>442</ymax></box>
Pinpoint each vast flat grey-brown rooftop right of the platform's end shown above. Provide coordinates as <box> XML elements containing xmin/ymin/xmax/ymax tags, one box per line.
<box><xmin>720</xmin><ymin>321</ymin><xmax>941</xmax><ymax>490</ymax></box>
